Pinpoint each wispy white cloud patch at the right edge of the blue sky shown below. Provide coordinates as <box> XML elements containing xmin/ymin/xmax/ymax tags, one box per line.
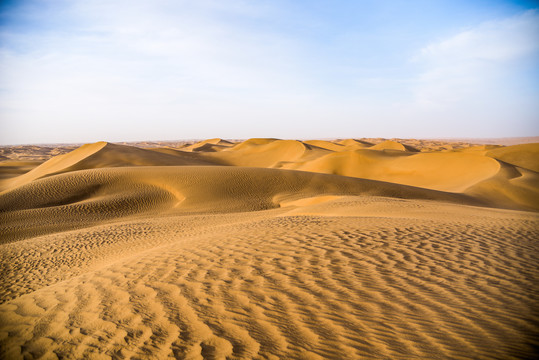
<box><xmin>414</xmin><ymin>10</ymin><xmax>539</xmax><ymax>109</ymax></box>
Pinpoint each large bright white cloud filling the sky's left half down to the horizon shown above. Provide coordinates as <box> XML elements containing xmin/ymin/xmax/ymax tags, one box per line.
<box><xmin>0</xmin><ymin>0</ymin><xmax>326</xmax><ymax>142</ymax></box>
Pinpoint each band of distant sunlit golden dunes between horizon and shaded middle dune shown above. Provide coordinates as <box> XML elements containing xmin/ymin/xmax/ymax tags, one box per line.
<box><xmin>0</xmin><ymin>138</ymin><xmax>539</xmax><ymax>210</ymax></box>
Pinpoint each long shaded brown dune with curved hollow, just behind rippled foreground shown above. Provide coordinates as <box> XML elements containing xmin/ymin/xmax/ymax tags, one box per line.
<box><xmin>0</xmin><ymin>166</ymin><xmax>483</xmax><ymax>242</ymax></box>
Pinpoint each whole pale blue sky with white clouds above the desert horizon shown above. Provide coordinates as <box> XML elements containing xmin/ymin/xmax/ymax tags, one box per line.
<box><xmin>0</xmin><ymin>0</ymin><xmax>539</xmax><ymax>144</ymax></box>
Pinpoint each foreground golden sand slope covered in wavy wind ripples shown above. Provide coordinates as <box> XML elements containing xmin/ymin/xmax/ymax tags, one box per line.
<box><xmin>0</xmin><ymin>196</ymin><xmax>539</xmax><ymax>359</ymax></box>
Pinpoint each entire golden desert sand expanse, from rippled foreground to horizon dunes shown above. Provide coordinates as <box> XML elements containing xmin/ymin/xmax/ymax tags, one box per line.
<box><xmin>0</xmin><ymin>138</ymin><xmax>539</xmax><ymax>359</ymax></box>
